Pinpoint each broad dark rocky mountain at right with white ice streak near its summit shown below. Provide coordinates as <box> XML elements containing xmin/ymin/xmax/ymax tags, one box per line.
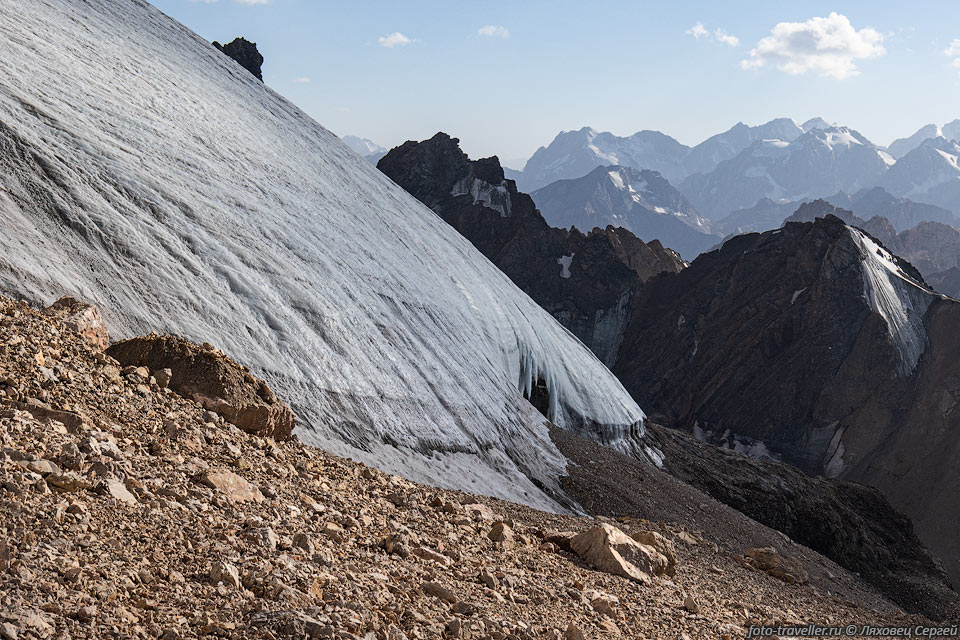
<box><xmin>614</xmin><ymin>215</ymin><xmax>960</xmax><ymax>592</ymax></box>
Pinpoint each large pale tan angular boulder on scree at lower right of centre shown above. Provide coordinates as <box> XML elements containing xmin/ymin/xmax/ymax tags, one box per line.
<box><xmin>570</xmin><ymin>523</ymin><xmax>670</xmax><ymax>583</ymax></box>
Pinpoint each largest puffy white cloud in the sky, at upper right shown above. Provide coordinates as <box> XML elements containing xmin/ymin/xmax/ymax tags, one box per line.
<box><xmin>740</xmin><ymin>12</ymin><xmax>887</xmax><ymax>80</ymax></box>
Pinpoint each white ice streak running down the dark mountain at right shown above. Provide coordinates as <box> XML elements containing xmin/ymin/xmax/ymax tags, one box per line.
<box><xmin>847</xmin><ymin>227</ymin><xmax>936</xmax><ymax>375</ymax></box>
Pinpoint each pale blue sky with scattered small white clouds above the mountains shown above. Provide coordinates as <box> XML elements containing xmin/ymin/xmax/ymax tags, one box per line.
<box><xmin>152</xmin><ymin>0</ymin><xmax>960</xmax><ymax>165</ymax></box>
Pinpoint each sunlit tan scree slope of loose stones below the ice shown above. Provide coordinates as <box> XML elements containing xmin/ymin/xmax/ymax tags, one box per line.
<box><xmin>0</xmin><ymin>298</ymin><xmax>936</xmax><ymax>640</ymax></box>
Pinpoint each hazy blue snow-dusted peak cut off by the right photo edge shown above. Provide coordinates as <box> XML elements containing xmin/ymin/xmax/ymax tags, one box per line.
<box><xmin>880</xmin><ymin>137</ymin><xmax>960</xmax><ymax>211</ymax></box>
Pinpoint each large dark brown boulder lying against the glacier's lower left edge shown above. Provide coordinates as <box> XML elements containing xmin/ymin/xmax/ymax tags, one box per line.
<box><xmin>107</xmin><ymin>335</ymin><xmax>295</xmax><ymax>440</ymax></box>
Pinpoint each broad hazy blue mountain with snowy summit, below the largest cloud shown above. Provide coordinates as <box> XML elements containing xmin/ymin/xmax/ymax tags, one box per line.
<box><xmin>679</xmin><ymin>127</ymin><xmax>894</xmax><ymax>219</ymax></box>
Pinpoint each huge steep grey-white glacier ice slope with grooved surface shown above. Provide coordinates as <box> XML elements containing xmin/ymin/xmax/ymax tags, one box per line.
<box><xmin>0</xmin><ymin>0</ymin><xmax>644</xmax><ymax>508</ymax></box>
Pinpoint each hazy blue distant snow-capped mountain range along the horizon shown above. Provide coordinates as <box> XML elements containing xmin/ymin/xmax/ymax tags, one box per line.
<box><xmin>496</xmin><ymin>118</ymin><xmax>960</xmax><ymax>245</ymax></box>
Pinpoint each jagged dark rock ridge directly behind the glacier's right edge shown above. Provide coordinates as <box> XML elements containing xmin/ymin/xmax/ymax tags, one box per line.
<box><xmin>377</xmin><ymin>133</ymin><xmax>684</xmax><ymax>366</ymax></box>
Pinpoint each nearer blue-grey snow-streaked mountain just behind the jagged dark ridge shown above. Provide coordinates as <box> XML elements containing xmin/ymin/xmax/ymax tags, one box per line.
<box><xmin>530</xmin><ymin>166</ymin><xmax>720</xmax><ymax>260</ymax></box>
